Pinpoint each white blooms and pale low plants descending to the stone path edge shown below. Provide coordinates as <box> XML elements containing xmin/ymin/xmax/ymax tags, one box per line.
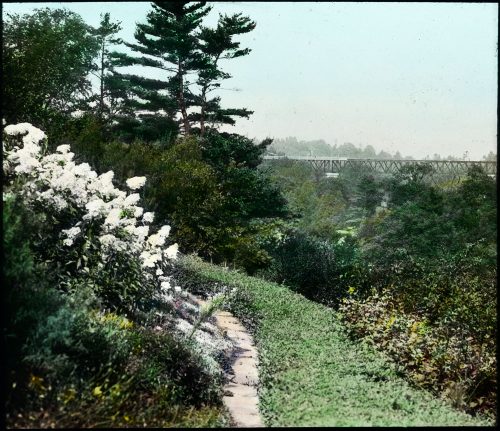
<box><xmin>3</xmin><ymin>123</ymin><xmax>233</xmax><ymax>378</ymax></box>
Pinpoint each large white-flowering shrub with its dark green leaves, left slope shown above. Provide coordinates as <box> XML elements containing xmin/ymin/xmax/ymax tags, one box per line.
<box><xmin>3</xmin><ymin>123</ymin><xmax>179</xmax><ymax>308</ymax></box>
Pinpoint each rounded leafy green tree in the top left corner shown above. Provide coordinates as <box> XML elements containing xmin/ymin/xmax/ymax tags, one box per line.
<box><xmin>2</xmin><ymin>8</ymin><xmax>98</xmax><ymax>133</ymax></box>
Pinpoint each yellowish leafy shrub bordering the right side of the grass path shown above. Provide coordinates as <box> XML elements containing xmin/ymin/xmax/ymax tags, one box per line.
<box><xmin>339</xmin><ymin>293</ymin><xmax>496</xmax><ymax>420</ymax></box>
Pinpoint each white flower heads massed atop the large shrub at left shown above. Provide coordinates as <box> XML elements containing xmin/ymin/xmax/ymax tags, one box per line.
<box><xmin>3</xmin><ymin>123</ymin><xmax>178</xmax><ymax>284</ymax></box>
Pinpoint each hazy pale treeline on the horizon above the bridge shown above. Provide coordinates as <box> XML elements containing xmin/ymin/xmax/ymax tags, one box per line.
<box><xmin>268</xmin><ymin>136</ymin><xmax>496</xmax><ymax>161</ymax></box>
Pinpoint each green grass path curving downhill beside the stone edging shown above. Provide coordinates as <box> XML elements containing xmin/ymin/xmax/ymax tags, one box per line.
<box><xmin>181</xmin><ymin>257</ymin><xmax>493</xmax><ymax>426</ymax></box>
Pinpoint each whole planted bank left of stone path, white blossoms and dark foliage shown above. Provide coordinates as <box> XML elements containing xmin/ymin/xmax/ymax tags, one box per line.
<box><xmin>3</xmin><ymin>123</ymin><xmax>232</xmax><ymax>427</ymax></box>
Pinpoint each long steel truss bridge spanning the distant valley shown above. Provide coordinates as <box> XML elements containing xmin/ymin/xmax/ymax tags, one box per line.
<box><xmin>264</xmin><ymin>155</ymin><xmax>497</xmax><ymax>181</ymax></box>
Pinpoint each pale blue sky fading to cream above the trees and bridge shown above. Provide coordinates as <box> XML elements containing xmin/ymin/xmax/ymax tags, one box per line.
<box><xmin>3</xmin><ymin>2</ymin><xmax>498</xmax><ymax>160</ymax></box>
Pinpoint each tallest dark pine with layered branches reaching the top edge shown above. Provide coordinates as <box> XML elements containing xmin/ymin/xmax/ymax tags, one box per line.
<box><xmin>109</xmin><ymin>2</ymin><xmax>211</xmax><ymax>135</ymax></box>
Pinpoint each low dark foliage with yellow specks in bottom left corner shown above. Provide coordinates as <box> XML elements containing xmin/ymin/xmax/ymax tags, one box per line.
<box><xmin>7</xmin><ymin>296</ymin><xmax>225</xmax><ymax>427</ymax></box>
